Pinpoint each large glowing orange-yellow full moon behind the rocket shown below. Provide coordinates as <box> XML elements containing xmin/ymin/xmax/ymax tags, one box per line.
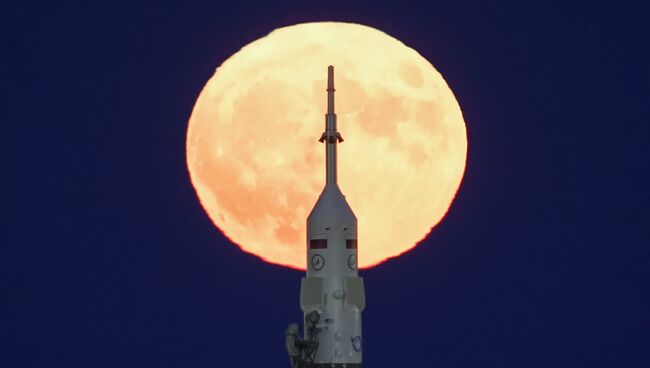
<box><xmin>186</xmin><ymin>22</ymin><xmax>467</xmax><ymax>269</ymax></box>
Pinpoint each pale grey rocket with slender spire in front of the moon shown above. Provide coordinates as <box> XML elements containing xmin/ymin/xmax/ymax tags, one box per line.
<box><xmin>285</xmin><ymin>65</ymin><xmax>366</xmax><ymax>368</ymax></box>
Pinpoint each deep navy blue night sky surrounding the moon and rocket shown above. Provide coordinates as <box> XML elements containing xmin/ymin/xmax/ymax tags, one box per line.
<box><xmin>5</xmin><ymin>1</ymin><xmax>650</xmax><ymax>368</ymax></box>
